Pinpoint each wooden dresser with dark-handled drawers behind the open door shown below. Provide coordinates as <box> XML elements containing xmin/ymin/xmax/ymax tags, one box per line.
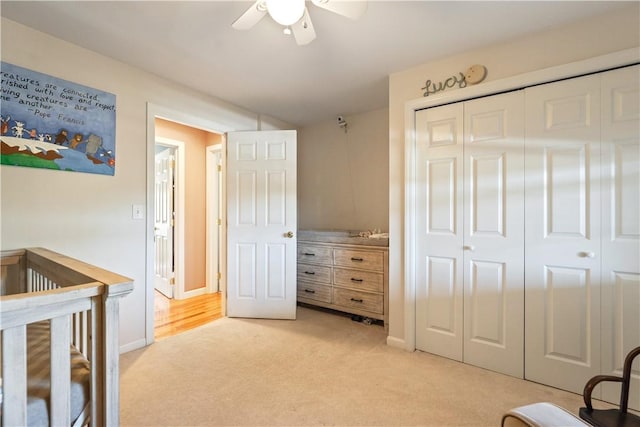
<box><xmin>298</xmin><ymin>230</ymin><xmax>389</xmax><ymax>328</ymax></box>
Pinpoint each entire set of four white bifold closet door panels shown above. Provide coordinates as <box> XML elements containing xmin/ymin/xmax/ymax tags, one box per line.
<box><xmin>412</xmin><ymin>65</ymin><xmax>640</xmax><ymax>404</ymax></box>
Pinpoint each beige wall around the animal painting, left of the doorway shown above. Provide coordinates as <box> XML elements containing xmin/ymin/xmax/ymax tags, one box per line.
<box><xmin>0</xmin><ymin>18</ymin><xmax>289</xmax><ymax>351</ymax></box>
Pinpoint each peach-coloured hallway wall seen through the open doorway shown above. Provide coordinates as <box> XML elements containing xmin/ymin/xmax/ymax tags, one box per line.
<box><xmin>156</xmin><ymin>119</ymin><xmax>212</xmax><ymax>292</ymax></box>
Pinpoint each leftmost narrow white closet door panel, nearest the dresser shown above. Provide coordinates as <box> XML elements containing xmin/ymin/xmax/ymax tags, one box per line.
<box><xmin>415</xmin><ymin>103</ymin><xmax>464</xmax><ymax>361</ymax></box>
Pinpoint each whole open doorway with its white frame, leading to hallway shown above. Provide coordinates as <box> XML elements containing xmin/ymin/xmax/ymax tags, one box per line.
<box><xmin>145</xmin><ymin>104</ymin><xmax>234</xmax><ymax>344</ymax></box>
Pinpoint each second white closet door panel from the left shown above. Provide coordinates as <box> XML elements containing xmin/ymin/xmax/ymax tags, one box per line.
<box><xmin>463</xmin><ymin>91</ymin><xmax>524</xmax><ymax>378</ymax></box>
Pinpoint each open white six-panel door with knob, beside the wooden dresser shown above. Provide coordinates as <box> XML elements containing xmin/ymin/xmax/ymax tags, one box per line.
<box><xmin>227</xmin><ymin>131</ymin><xmax>297</xmax><ymax>319</ymax></box>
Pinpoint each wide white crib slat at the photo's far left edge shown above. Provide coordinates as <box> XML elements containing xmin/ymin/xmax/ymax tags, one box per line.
<box><xmin>2</xmin><ymin>325</ymin><xmax>27</xmax><ymax>427</ymax></box>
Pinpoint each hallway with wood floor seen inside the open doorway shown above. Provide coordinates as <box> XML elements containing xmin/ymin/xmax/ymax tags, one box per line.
<box><xmin>154</xmin><ymin>118</ymin><xmax>221</xmax><ymax>339</ymax></box>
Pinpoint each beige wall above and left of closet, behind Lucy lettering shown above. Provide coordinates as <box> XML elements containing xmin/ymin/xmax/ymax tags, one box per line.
<box><xmin>389</xmin><ymin>2</ymin><xmax>640</xmax><ymax>346</ymax></box>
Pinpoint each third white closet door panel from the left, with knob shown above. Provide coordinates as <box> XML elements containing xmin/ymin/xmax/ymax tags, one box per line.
<box><xmin>525</xmin><ymin>75</ymin><xmax>602</xmax><ymax>393</ymax></box>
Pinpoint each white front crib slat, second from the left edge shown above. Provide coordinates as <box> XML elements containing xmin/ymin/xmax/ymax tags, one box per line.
<box><xmin>50</xmin><ymin>315</ymin><xmax>71</xmax><ymax>426</ymax></box>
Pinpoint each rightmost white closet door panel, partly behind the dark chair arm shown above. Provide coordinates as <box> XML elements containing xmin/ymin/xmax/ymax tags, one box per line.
<box><xmin>602</xmin><ymin>66</ymin><xmax>640</xmax><ymax>410</ymax></box>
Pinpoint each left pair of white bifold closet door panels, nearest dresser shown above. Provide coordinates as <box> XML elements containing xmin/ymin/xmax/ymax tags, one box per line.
<box><xmin>415</xmin><ymin>91</ymin><xmax>524</xmax><ymax>377</ymax></box>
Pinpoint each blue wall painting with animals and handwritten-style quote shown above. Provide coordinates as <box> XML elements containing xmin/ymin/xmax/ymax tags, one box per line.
<box><xmin>0</xmin><ymin>62</ymin><xmax>116</xmax><ymax>175</ymax></box>
